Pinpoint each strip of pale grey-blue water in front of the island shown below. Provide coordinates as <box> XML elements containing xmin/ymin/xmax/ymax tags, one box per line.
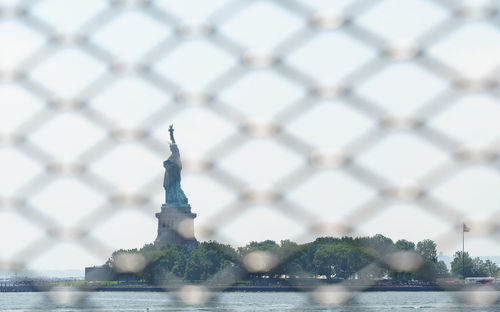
<box><xmin>0</xmin><ymin>292</ymin><xmax>500</xmax><ymax>312</ymax></box>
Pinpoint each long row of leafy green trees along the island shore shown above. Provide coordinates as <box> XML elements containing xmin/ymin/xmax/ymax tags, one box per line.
<box><xmin>106</xmin><ymin>234</ymin><xmax>499</xmax><ymax>284</ymax></box>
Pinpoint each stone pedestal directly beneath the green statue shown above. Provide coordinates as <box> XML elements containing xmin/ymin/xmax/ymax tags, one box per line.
<box><xmin>155</xmin><ymin>204</ymin><xmax>196</xmax><ymax>245</ymax></box>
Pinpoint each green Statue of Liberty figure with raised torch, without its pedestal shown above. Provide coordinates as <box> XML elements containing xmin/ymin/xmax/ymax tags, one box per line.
<box><xmin>163</xmin><ymin>125</ymin><xmax>189</xmax><ymax>207</ymax></box>
